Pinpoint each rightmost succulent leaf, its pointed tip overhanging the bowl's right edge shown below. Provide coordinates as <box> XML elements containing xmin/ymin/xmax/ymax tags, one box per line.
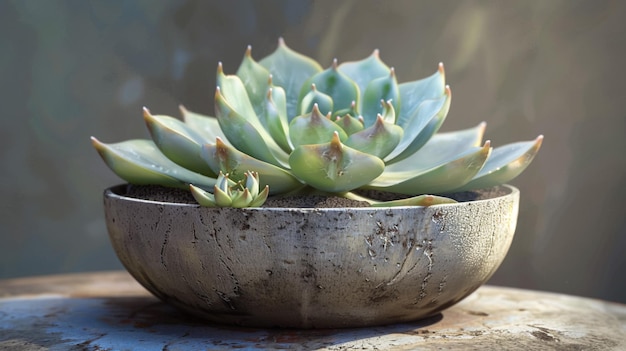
<box><xmin>454</xmin><ymin>135</ymin><xmax>543</xmax><ymax>191</ymax></box>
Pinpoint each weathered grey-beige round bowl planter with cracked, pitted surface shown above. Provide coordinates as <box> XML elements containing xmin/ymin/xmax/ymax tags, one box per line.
<box><xmin>104</xmin><ymin>185</ymin><xmax>519</xmax><ymax>328</ymax></box>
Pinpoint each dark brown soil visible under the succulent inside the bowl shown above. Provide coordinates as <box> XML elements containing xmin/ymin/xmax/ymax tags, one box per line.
<box><xmin>124</xmin><ymin>185</ymin><xmax>506</xmax><ymax>208</ymax></box>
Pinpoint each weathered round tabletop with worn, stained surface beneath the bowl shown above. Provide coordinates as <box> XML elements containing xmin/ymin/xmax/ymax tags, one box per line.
<box><xmin>0</xmin><ymin>272</ymin><xmax>626</xmax><ymax>351</ymax></box>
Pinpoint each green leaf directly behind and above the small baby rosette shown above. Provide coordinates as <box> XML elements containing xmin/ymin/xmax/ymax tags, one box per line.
<box><xmin>201</xmin><ymin>139</ymin><xmax>302</xmax><ymax>194</ymax></box>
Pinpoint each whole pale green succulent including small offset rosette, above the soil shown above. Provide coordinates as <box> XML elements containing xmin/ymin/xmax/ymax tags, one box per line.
<box><xmin>92</xmin><ymin>39</ymin><xmax>543</xmax><ymax>207</ymax></box>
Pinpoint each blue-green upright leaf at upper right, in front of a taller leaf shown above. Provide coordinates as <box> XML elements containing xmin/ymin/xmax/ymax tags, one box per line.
<box><xmin>385</xmin><ymin>87</ymin><xmax>452</xmax><ymax>164</ymax></box>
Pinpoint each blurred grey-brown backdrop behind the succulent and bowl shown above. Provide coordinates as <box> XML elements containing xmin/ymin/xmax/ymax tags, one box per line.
<box><xmin>0</xmin><ymin>0</ymin><xmax>626</xmax><ymax>302</ymax></box>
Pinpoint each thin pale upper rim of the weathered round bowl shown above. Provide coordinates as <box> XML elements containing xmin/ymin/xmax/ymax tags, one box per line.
<box><xmin>104</xmin><ymin>183</ymin><xmax>520</xmax><ymax>212</ymax></box>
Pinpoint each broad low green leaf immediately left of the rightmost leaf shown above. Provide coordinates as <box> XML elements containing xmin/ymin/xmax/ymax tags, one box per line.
<box><xmin>366</xmin><ymin>141</ymin><xmax>491</xmax><ymax>195</ymax></box>
